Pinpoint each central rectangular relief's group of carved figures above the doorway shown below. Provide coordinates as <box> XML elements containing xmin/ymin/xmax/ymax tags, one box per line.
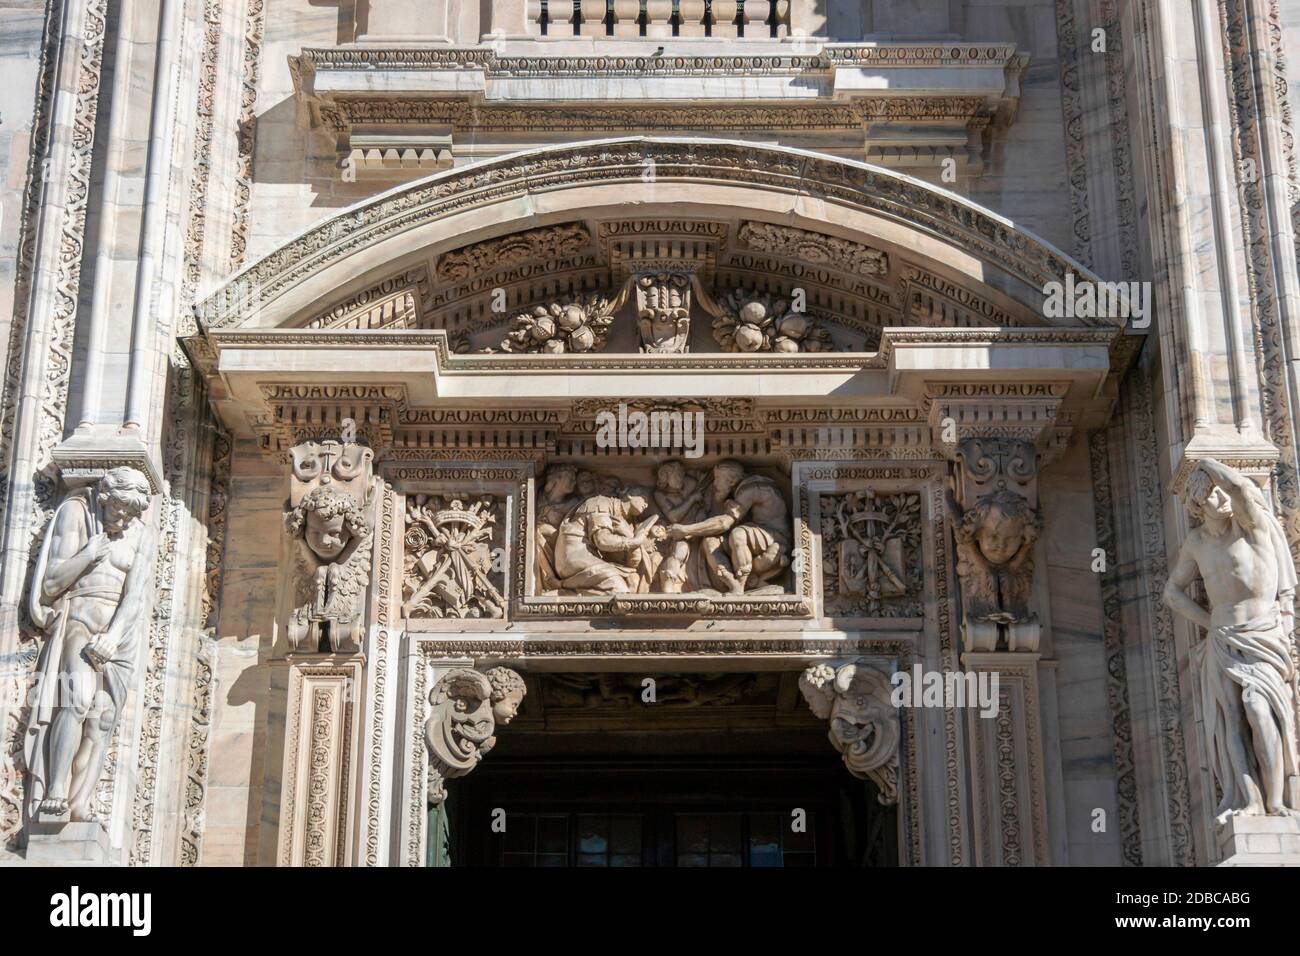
<box><xmin>533</xmin><ymin>459</ymin><xmax>792</xmax><ymax>596</ymax></box>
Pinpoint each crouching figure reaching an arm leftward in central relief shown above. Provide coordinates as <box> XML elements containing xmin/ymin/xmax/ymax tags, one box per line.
<box><xmin>667</xmin><ymin>460</ymin><xmax>790</xmax><ymax>594</ymax></box>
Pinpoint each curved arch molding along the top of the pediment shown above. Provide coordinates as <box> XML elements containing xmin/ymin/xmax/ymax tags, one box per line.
<box><xmin>195</xmin><ymin>137</ymin><xmax>1110</xmax><ymax>330</ymax></box>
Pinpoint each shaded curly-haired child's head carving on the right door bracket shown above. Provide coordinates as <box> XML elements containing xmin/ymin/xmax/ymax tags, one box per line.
<box><xmin>948</xmin><ymin>488</ymin><xmax>1043</xmax><ymax>650</ymax></box>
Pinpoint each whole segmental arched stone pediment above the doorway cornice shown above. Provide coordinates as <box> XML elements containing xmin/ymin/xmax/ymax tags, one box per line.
<box><xmin>196</xmin><ymin>138</ymin><xmax>1108</xmax><ymax>352</ymax></box>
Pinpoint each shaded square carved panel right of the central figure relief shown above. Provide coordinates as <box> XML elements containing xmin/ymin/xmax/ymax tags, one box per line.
<box><xmin>822</xmin><ymin>489</ymin><xmax>922</xmax><ymax>618</ymax></box>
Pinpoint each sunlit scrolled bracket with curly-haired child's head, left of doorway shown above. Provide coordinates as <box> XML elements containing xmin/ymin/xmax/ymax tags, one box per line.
<box><xmin>285</xmin><ymin>441</ymin><xmax>376</xmax><ymax>653</ymax></box>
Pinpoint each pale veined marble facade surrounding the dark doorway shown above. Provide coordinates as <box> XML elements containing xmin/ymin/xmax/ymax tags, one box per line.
<box><xmin>0</xmin><ymin>0</ymin><xmax>1300</xmax><ymax>866</ymax></box>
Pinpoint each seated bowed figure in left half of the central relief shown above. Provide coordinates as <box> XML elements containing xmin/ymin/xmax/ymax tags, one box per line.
<box><xmin>555</xmin><ymin>488</ymin><xmax>663</xmax><ymax>594</ymax></box>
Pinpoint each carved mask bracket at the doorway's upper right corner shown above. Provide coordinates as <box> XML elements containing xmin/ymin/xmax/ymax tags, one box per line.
<box><xmin>800</xmin><ymin>661</ymin><xmax>900</xmax><ymax>805</ymax></box>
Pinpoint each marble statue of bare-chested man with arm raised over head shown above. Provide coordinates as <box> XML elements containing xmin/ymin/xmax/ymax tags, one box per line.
<box><xmin>1165</xmin><ymin>458</ymin><xmax>1300</xmax><ymax>823</ymax></box>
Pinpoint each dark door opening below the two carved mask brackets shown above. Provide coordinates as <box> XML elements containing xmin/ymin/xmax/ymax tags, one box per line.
<box><xmin>449</xmin><ymin>753</ymin><xmax>897</xmax><ymax>868</ymax></box>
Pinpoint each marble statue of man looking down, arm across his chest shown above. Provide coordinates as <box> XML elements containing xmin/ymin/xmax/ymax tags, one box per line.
<box><xmin>25</xmin><ymin>466</ymin><xmax>153</xmax><ymax>821</ymax></box>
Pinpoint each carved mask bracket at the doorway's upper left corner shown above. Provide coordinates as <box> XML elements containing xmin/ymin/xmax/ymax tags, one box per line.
<box><xmin>424</xmin><ymin>667</ymin><xmax>528</xmax><ymax>804</ymax></box>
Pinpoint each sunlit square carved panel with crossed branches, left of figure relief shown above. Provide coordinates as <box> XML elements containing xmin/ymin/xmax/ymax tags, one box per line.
<box><xmin>402</xmin><ymin>494</ymin><xmax>506</xmax><ymax>618</ymax></box>
